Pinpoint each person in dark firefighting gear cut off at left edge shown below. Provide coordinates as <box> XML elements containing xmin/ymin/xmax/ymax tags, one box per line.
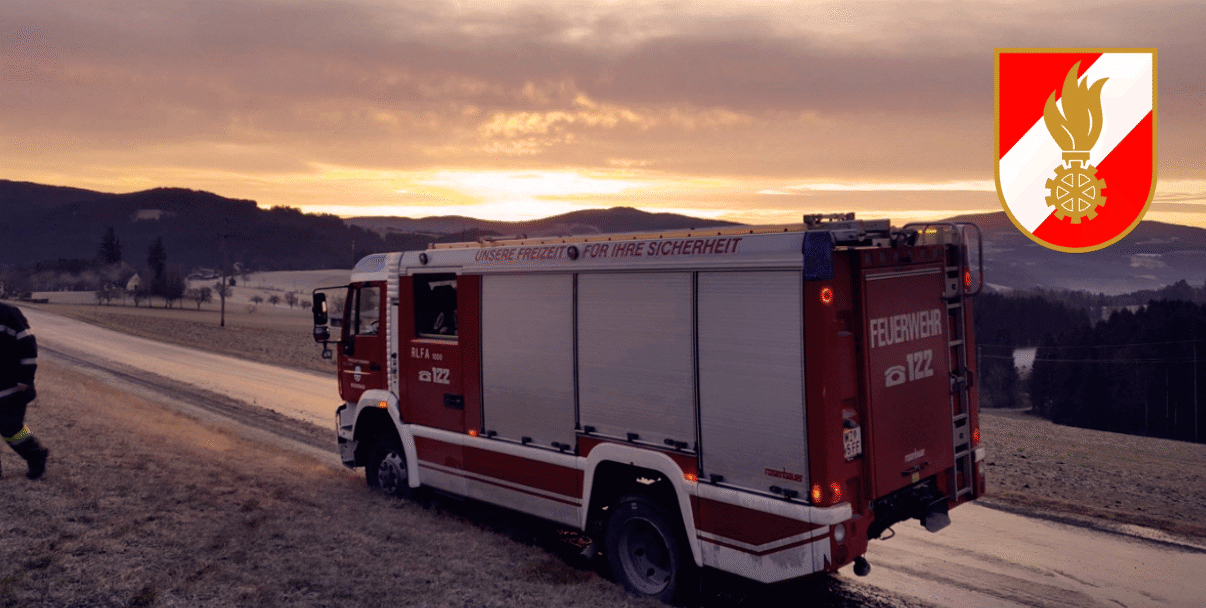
<box><xmin>0</xmin><ymin>302</ymin><xmax>49</xmax><ymax>479</ymax></box>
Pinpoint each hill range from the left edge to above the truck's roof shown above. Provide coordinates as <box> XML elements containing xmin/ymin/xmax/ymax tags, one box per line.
<box><xmin>0</xmin><ymin>180</ymin><xmax>727</xmax><ymax>270</ymax></box>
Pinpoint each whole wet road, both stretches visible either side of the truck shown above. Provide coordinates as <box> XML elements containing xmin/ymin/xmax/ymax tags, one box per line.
<box><xmin>24</xmin><ymin>309</ymin><xmax>1206</xmax><ymax>608</ymax></box>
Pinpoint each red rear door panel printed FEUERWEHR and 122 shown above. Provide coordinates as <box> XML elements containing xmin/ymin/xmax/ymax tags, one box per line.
<box><xmin>862</xmin><ymin>264</ymin><xmax>954</xmax><ymax>497</ymax></box>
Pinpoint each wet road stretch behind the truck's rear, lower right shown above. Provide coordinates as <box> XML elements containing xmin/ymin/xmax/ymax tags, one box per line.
<box><xmin>843</xmin><ymin>503</ymin><xmax>1206</xmax><ymax>608</ymax></box>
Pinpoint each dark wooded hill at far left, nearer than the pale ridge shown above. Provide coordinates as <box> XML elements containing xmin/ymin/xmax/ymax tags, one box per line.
<box><xmin>0</xmin><ymin>180</ymin><xmax>385</xmax><ymax>270</ymax></box>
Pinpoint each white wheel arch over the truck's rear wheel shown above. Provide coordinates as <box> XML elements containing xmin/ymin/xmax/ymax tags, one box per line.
<box><xmin>579</xmin><ymin>444</ymin><xmax>703</xmax><ymax>567</ymax></box>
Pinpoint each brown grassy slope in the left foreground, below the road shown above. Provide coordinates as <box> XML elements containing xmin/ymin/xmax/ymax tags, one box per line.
<box><xmin>0</xmin><ymin>364</ymin><xmax>655</xmax><ymax>607</ymax></box>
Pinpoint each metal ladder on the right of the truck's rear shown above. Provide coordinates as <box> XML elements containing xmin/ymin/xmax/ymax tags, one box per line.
<box><xmin>902</xmin><ymin>223</ymin><xmax>984</xmax><ymax>502</ymax></box>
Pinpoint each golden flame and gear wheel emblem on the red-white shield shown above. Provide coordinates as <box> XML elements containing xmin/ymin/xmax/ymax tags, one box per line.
<box><xmin>1043</xmin><ymin>62</ymin><xmax>1108</xmax><ymax>223</ymax></box>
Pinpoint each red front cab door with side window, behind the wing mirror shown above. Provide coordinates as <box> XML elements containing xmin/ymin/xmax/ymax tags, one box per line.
<box><xmin>339</xmin><ymin>282</ymin><xmax>387</xmax><ymax>403</ymax></box>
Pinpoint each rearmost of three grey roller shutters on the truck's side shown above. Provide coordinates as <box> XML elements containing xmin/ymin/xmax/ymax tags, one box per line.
<box><xmin>697</xmin><ymin>271</ymin><xmax>809</xmax><ymax>497</ymax></box>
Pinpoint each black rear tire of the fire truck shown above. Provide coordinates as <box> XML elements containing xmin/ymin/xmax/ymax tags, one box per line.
<box><xmin>605</xmin><ymin>496</ymin><xmax>698</xmax><ymax>603</ymax></box>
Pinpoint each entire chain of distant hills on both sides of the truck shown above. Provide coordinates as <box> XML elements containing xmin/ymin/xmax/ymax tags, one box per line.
<box><xmin>9</xmin><ymin>180</ymin><xmax>1206</xmax><ymax>294</ymax></box>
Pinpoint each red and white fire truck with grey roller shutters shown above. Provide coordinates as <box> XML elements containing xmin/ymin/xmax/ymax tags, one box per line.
<box><xmin>314</xmin><ymin>214</ymin><xmax>984</xmax><ymax>601</ymax></box>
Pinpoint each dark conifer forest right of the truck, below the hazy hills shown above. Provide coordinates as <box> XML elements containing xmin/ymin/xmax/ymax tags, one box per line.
<box><xmin>974</xmin><ymin>287</ymin><xmax>1206</xmax><ymax>442</ymax></box>
